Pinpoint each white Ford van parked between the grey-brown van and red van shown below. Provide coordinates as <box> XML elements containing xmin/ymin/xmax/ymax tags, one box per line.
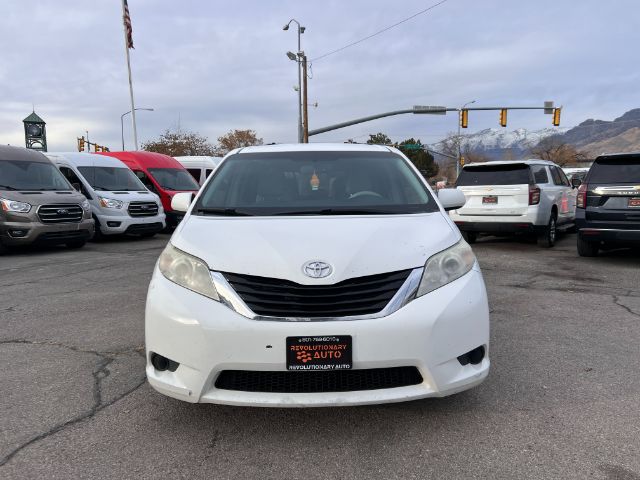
<box><xmin>45</xmin><ymin>152</ymin><xmax>165</xmax><ymax>238</ymax></box>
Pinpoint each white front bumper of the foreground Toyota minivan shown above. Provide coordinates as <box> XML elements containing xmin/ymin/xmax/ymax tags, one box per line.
<box><xmin>145</xmin><ymin>266</ymin><xmax>489</xmax><ymax>407</ymax></box>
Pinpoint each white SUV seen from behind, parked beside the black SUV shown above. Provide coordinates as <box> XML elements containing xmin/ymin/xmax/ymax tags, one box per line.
<box><xmin>451</xmin><ymin>160</ymin><xmax>577</xmax><ymax>247</ymax></box>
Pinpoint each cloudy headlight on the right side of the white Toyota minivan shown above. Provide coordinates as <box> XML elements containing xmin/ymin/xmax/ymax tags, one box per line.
<box><xmin>418</xmin><ymin>240</ymin><xmax>476</xmax><ymax>297</ymax></box>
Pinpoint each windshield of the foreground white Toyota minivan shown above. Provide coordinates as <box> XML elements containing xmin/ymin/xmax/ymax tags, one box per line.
<box><xmin>193</xmin><ymin>152</ymin><xmax>438</xmax><ymax>215</ymax></box>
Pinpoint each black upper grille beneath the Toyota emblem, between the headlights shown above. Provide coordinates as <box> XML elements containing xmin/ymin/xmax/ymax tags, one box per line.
<box><xmin>223</xmin><ymin>270</ymin><xmax>411</xmax><ymax>317</ymax></box>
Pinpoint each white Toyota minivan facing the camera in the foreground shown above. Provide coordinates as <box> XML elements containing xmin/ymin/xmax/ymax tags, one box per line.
<box><xmin>145</xmin><ymin>144</ymin><xmax>489</xmax><ymax>407</ymax></box>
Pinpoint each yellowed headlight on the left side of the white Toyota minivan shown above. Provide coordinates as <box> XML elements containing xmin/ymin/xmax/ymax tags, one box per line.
<box><xmin>158</xmin><ymin>243</ymin><xmax>220</xmax><ymax>301</ymax></box>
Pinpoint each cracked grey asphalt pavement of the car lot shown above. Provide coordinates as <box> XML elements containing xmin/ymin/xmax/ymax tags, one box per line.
<box><xmin>0</xmin><ymin>235</ymin><xmax>640</xmax><ymax>480</ymax></box>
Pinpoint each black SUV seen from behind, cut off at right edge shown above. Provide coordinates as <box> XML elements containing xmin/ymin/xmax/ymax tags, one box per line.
<box><xmin>576</xmin><ymin>153</ymin><xmax>640</xmax><ymax>257</ymax></box>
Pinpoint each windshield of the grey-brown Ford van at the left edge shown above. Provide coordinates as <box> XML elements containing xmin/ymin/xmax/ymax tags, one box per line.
<box><xmin>0</xmin><ymin>160</ymin><xmax>72</xmax><ymax>190</ymax></box>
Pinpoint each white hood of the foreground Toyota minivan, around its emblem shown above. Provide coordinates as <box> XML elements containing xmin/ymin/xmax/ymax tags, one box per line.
<box><xmin>171</xmin><ymin>212</ymin><xmax>460</xmax><ymax>285</ymax></box>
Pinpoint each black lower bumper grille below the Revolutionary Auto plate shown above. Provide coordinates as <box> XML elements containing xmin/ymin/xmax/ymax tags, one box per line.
<box><xmin>215</xmin><ymin>367</ymin><xmax>422</xmax><ymax>393</ymax></box>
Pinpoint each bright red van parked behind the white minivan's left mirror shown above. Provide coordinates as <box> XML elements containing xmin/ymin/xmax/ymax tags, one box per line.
<box><xmin>98</xmin><ymin>152</ymin><xmax>200</xmax><ymax>228</ymax></box>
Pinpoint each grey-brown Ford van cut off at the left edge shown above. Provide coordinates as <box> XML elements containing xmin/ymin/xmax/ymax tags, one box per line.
<box><xmin>0</xmin><ymin>145</ymin><xmax>94</xmax><ymax>253</ymax></box>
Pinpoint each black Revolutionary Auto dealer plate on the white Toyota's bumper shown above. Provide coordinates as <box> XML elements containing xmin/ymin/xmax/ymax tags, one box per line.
<box><xmin>287</xmin><ymin>335</ymin><xmax>353</xmax><ymax>370</ymax></box>
